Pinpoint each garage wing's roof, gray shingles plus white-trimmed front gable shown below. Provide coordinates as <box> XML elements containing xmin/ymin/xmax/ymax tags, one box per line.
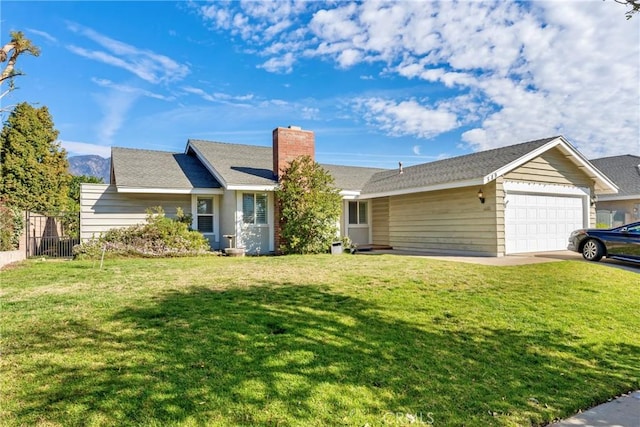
<box><xmin>362</xmin><ymin>136</ymin><xmax>616</xmax><ymax>197</ymax></box>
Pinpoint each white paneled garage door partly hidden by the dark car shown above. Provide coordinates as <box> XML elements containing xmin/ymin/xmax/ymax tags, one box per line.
<box><xmin>505</xmin><ymin>193</ymin><xmax>584</xmax><ymax>254</ymax></box>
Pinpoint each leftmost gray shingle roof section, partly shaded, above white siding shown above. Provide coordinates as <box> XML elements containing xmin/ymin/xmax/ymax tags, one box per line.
<box><xmin>111</xmin><ymin>147</ymin><xmax>220</xmax><ymax>189</ymax></box>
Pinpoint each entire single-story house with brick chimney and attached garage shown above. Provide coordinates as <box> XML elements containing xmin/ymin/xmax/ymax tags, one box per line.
<box><xmin>81</xmin><ymin>127</ymin><xmax>616</xmax><ymax>256</ymax></box>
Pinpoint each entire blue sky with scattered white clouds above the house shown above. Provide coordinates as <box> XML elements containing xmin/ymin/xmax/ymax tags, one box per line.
<box><xmin>0</xmin><ymin>0</ymin><xmax>640</xmax><ymax>168</ymax></box>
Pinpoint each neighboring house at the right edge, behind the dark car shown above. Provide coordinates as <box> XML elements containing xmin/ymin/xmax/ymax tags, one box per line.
<box><xmin>591</xmin><ymin>154</ymin><xmax>640</xmax><ymax>227</ymax></box>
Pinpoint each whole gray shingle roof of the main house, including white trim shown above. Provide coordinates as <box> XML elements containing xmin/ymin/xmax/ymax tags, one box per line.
<box><xmin>112</xmin><ymin>136</ymin><xmax>617</xmax><ymax>198</ymax></box>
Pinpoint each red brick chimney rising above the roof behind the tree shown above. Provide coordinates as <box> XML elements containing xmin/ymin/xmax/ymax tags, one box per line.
<box><xmin>273</xmin><ymin>126</ymin><xmax>315</xmax><ymax>177</ymax></box>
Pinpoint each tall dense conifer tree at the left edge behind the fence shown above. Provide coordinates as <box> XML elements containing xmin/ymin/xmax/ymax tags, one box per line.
<box><xmin>0</xmin><ymin>102</ymin><xmax>71</xmax><ymax>213</ymax></box>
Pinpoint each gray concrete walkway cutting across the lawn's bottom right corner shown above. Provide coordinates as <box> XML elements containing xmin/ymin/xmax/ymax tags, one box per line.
<box><xmin>549</xmin><ymin>391</ymin><xmax>640</xmax><ymax>427</ymax></box>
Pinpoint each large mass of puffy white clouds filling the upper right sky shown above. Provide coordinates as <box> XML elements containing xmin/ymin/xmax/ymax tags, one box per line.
<box><xmin>192</xmin><ymin>0</ymin><xmax>640</xmax><ymax>157</ymax></box>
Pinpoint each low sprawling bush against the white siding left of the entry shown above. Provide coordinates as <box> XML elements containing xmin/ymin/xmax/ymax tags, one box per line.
<box><xmin>73</xmin><ymin>206</ymin><xmax>210</xmax><ymax>259</ymax></box>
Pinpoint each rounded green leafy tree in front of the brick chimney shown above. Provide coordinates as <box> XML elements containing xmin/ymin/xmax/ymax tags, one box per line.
<box><xmin>276</xmin><ymin>156</ymin><xmax>342</xmax><ymax>254</ymax></box>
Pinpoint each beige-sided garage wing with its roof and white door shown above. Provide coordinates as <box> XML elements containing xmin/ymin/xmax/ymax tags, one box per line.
<box><xmin>361</xmin><ymin>137</ymin><xmax>616</xmax><ymax>256</ymax></box>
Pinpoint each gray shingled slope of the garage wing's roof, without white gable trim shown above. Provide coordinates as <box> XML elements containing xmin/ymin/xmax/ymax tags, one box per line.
<box><xmin>362</xmin><ymin>137</ymin><xmax>557</xmax><ymax>194</ymax></box>
